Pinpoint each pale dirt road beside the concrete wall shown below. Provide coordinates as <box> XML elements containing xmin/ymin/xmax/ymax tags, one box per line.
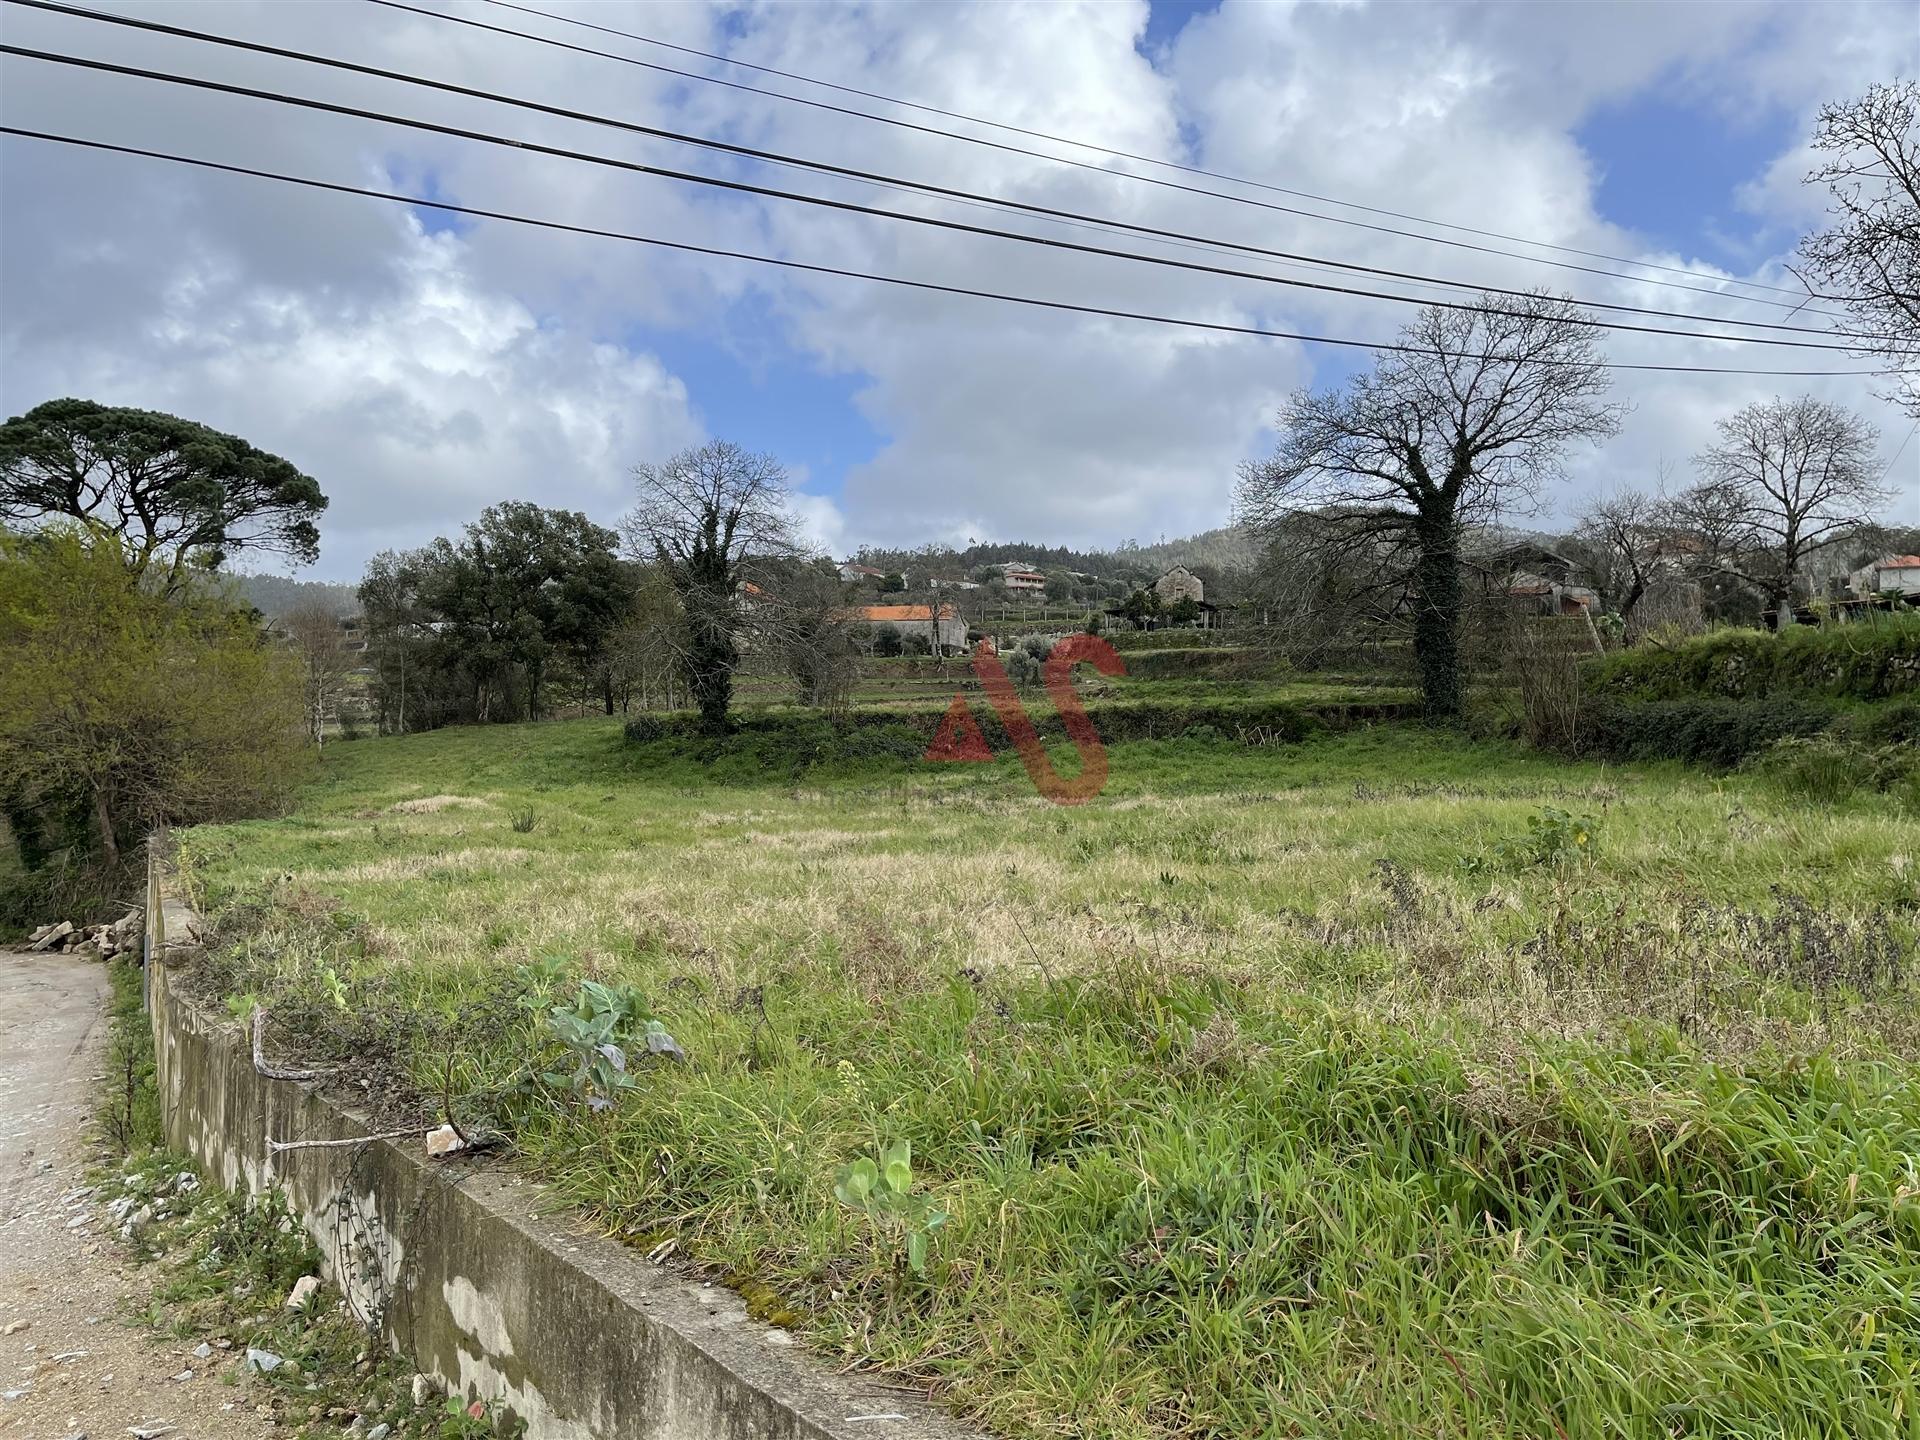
<box><xmin>0</xmin><ymin>950</ymin><xmax>275</xmax><ymax>1440</ymax></box>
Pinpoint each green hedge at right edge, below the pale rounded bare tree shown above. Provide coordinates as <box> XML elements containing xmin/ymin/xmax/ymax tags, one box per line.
<box><xmin>1582</xmin><ymin>616</ymin><xmax>1920</xmax><ymax>701</ymax></box>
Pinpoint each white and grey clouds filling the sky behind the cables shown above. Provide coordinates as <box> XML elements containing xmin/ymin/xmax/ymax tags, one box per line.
<box><xmin>0</xmin><ymin>0</ymin><xmax>1920</xmax><ymax>574</ymax></box>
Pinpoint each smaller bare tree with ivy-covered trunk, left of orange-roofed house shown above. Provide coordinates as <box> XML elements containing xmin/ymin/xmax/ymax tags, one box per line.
<box><xmin>624</xmin><ymin>440</ymin><xmax>801</xmax><ymax>733</ymax></box>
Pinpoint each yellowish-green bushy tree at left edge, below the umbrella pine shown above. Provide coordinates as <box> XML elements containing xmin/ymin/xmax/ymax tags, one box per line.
<box><xmin>0</xmin><ymin>524</ymin><xmax>307</xmax><ymax>866</ymax></box>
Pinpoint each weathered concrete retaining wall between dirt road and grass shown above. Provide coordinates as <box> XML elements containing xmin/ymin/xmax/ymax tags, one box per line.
<box><xmin>148</xmin><ymin>856</ymin><xmax>979</xmax><ymax>1440</ymax></box>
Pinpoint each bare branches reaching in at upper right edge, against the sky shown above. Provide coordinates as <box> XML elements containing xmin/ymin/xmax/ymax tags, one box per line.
<box><xmin>1801</xmin><ymin>81</ymin><xmax>1920</xmax><ymax>419</ymax></box>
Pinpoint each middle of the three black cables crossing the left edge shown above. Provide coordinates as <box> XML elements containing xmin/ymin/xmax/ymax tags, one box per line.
<box><xmin>0</xmin><ymin>44</ymin><xmax>1889</xmax><ymax>353</ymax></box>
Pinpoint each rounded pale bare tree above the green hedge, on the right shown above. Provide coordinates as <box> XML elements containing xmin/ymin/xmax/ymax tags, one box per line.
<box><xmin>1678</xmin><ymin>396</ymin><xmax>1893</xmax><ymax>630</ymax></box>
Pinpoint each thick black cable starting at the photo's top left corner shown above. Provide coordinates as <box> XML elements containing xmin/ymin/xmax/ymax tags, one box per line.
<box><xmin>8</xmin><ymin>0</ymin><xmax>1884</xmax><ymax>349</ymax></box>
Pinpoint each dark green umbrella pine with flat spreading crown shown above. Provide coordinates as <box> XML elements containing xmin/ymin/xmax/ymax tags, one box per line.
<box><xmin>0</xmin><ymin>399</ymin><xmax>326</xmax><ymax>589</ymax></box>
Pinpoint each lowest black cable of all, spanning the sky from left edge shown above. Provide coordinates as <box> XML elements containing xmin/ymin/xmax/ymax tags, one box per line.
<box><xmin>0</xmin><ymin>125</ymin><xmax>1878</xmax><ymax>378</ymax></box>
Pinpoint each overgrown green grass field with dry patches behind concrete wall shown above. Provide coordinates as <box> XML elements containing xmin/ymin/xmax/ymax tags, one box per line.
<box><xmin>182</xmin><ymin>718</ymin><xmax>1920</xmax><ymax>1440</ymax></box>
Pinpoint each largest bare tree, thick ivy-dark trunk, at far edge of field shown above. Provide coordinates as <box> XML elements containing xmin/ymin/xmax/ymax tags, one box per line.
<box><xmin>1238</xmin><ymin>294</ymin><xmax>1622</xmax><ymax>722</ymax></box>
